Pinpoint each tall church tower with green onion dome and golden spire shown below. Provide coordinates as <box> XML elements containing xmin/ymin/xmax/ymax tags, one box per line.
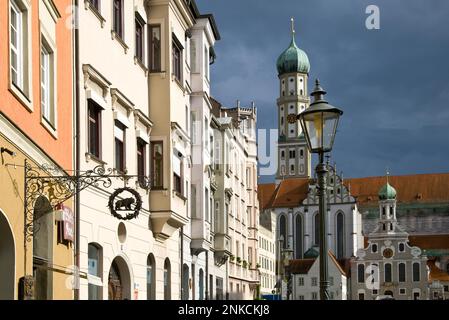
<box><xmin>276</xmin><ymin>18</ymin><xmax>311</xmax><ymax>182</ymax></box>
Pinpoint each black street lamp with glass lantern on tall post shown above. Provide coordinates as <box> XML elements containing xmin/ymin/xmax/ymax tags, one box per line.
<box><xmin>297</xmin><ymin>79</ymin><xmax>343</xmax><ymax>300</ymax></box>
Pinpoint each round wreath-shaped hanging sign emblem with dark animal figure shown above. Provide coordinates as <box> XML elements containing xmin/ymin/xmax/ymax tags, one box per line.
<box><xmin>108</xmin><ymin>188</ymin><xmax>142</xmax><ymax>220</ymax></box>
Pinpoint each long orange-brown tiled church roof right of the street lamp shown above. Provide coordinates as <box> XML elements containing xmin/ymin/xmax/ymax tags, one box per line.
<box><xmin>344</xmin><ymin>173</ymin><xmax>449</xmax><ymax>206</ymax></box>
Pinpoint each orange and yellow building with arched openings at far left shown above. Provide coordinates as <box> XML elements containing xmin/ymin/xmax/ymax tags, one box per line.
<box><xmin>0</xmin><ymin>0</ymin><xmax>74</xmax><ymax>300</ymax></box>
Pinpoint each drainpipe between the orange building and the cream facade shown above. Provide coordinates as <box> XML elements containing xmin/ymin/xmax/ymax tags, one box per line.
<box><xmin>72</xmin><ymin>0</ymin><xmax>81</xmax><ymax>300</ymax></box>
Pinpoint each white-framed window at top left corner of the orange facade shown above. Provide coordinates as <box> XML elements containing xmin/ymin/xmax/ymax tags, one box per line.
<box><xmin>8</xmin><ymin>0</ymin><xmax>33</xmax><ymax>112</ymax></box>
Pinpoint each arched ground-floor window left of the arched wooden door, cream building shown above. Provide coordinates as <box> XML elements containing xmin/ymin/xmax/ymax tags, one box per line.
<box><xmin>87</xmin><ymin>243</ymin><xmax>103</xmax><ymax>300</ymax></box>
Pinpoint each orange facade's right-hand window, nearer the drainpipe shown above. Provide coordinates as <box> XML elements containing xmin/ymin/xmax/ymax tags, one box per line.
<box><xmin>41</xmin><ymin>36</ymin><xmax>56</xmax><ymax>128</ymax></box>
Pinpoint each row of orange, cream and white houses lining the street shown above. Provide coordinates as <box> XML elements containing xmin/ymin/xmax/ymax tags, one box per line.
<box><xmin>0</xmin><ymin>0</ymin><xmax>260</xmax><ymax>300</ymax></box>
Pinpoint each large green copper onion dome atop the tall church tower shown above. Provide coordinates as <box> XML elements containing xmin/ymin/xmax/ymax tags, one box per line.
<box><xmin>276</xmin><ymin>32</ymin><xmax>310</xmax><ymax>75</ymax></box>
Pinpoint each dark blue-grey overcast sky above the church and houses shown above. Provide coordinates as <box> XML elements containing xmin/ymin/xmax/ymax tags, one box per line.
<box><xmin>197</xmin><ymin>0</ymin><xmax>449</xmax><ymax>182</ymax></box>
